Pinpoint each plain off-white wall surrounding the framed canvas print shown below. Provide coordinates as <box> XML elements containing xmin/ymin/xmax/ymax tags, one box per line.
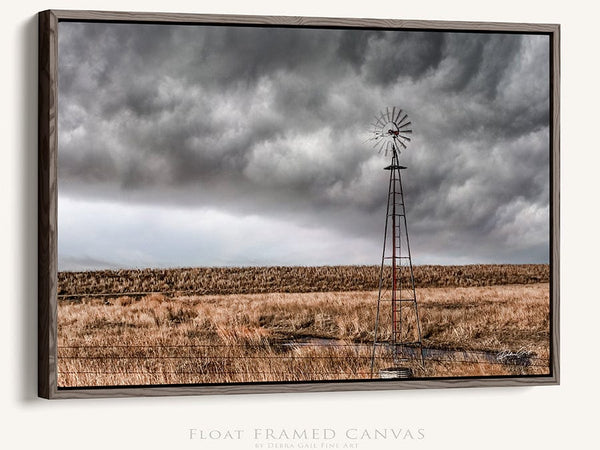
<box><xmin>0</xmin><ymin>0</ymin><xmax>600</xmax><ymax>450</ymax></box>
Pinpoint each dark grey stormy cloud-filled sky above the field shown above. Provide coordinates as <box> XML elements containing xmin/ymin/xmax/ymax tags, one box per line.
<box><xmin>58</xmin><ymin>22</ymin><xmax>549</xmax><ymax>270</ymax></box>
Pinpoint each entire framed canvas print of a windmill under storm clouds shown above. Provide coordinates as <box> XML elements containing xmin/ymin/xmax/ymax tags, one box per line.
<box><xmin>38</xmin><ymin>10</ymin><xmax>559</xmax><ymax>398</ymax></box>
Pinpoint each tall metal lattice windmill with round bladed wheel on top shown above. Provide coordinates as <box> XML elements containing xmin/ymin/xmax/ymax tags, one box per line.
<box><xmin>370</xmin><ymin>106</ymin><xmax>425</xmax><ymax>378</ymax></box>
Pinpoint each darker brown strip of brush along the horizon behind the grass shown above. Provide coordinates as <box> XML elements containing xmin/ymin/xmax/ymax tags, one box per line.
<box><xmin>58</xmin><ymin>264</ymin><xmax>549</xmax><ymax>296</ymax></box>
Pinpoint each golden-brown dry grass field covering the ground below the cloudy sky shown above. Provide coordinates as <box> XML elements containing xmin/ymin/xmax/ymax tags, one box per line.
<box><xmin>58</xmin><ymin>266</ymin><xmax>549</xmax><ymax>387</ymax></box>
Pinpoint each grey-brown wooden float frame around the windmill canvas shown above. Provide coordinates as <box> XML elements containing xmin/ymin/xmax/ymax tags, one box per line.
<box><xmin>38</xmin><ymin>10</ymin><xmax>560</xmax><ymax>399</ymax></box>
